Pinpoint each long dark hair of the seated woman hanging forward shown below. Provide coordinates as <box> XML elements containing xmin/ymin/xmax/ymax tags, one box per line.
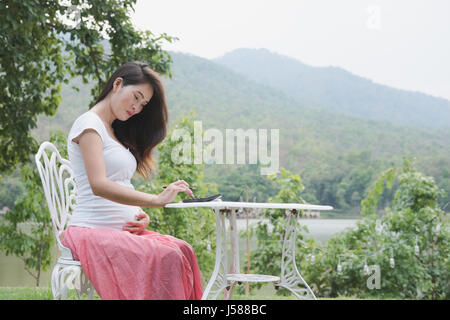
<box><xmin>94</xmin><ymin>61</ymin><xmax>168</xmax><ymax>178</ymax></box>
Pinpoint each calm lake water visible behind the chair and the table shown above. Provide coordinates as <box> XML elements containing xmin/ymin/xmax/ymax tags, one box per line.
<box><xmin>0</xmin><ymin>219</ymin><xmax>358</xmax><ymax>287</ymax></box>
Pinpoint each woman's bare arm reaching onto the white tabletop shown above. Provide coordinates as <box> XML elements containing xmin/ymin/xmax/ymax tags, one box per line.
<box><xmin>78</xmin><ymin>129</ymin><xmax>193</xmax><ymax>208</ymax></box>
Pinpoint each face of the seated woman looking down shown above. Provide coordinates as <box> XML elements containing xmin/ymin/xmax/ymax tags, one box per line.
<box><xmin>111</xmin><ymin>78</ymin><xmax>153</xmax><ymax>121</ymax></box>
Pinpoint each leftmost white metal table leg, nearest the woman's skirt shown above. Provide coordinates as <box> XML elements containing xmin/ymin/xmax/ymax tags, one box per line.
<box><xmin>202</xmin><ymin>208</ymin><xmax>227</xmax><ymax>300</ymax></box>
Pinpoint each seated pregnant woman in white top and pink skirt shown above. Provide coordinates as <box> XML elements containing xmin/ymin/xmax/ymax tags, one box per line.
<box><xmin>62</xmin><ymin>62</ymin><xmax>202</xmax><ymax>299</ymax></box>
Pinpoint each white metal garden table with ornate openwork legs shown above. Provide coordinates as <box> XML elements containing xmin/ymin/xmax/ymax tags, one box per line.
<box><xmin>165</xmin><ymin>199</ymin><xmax>333</xmax><ymax>300</ymax></box>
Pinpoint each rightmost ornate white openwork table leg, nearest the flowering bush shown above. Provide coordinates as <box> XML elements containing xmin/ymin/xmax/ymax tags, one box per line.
<box><xmin>275</xmin><ymin>209</ymin><xmax>316</xmax><ymax>300</ymax></box>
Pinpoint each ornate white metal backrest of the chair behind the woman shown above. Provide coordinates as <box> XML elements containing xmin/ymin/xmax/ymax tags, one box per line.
<box><xmin>35</xmin><ymin>141</ymin><xmax>77</xmax><ymax>250</ymax></box>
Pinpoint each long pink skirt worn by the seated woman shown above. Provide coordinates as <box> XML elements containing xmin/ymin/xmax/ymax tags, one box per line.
<box><xmin>62</xmin><ymin>226</ymin><xmax>203</xmax><ymax>300</ymax></box>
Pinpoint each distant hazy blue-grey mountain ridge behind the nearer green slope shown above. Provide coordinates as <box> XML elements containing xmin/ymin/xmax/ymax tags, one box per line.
<box><xmin>213</xmin><ymin>48</ymin><xmax>450</xmax><ymax>127</ymax></box>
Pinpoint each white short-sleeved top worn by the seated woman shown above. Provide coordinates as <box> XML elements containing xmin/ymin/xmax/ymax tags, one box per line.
<box><xmin>67</xmin><ymin>111</ymin><xmax>139</xmax><ymax>230</ymax></box>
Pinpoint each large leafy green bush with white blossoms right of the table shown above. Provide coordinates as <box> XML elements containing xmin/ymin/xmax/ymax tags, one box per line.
<box><xmin>302</xmin><ymin>160</ymin><xmax>450</xmax><ymax>299</ymax></box>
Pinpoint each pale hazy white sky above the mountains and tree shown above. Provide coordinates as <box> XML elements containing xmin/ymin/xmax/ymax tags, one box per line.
<box><xmin>132</xmin><ymin>0</ymin><xmax>450</xmax><ymax>100</ymax></box>
